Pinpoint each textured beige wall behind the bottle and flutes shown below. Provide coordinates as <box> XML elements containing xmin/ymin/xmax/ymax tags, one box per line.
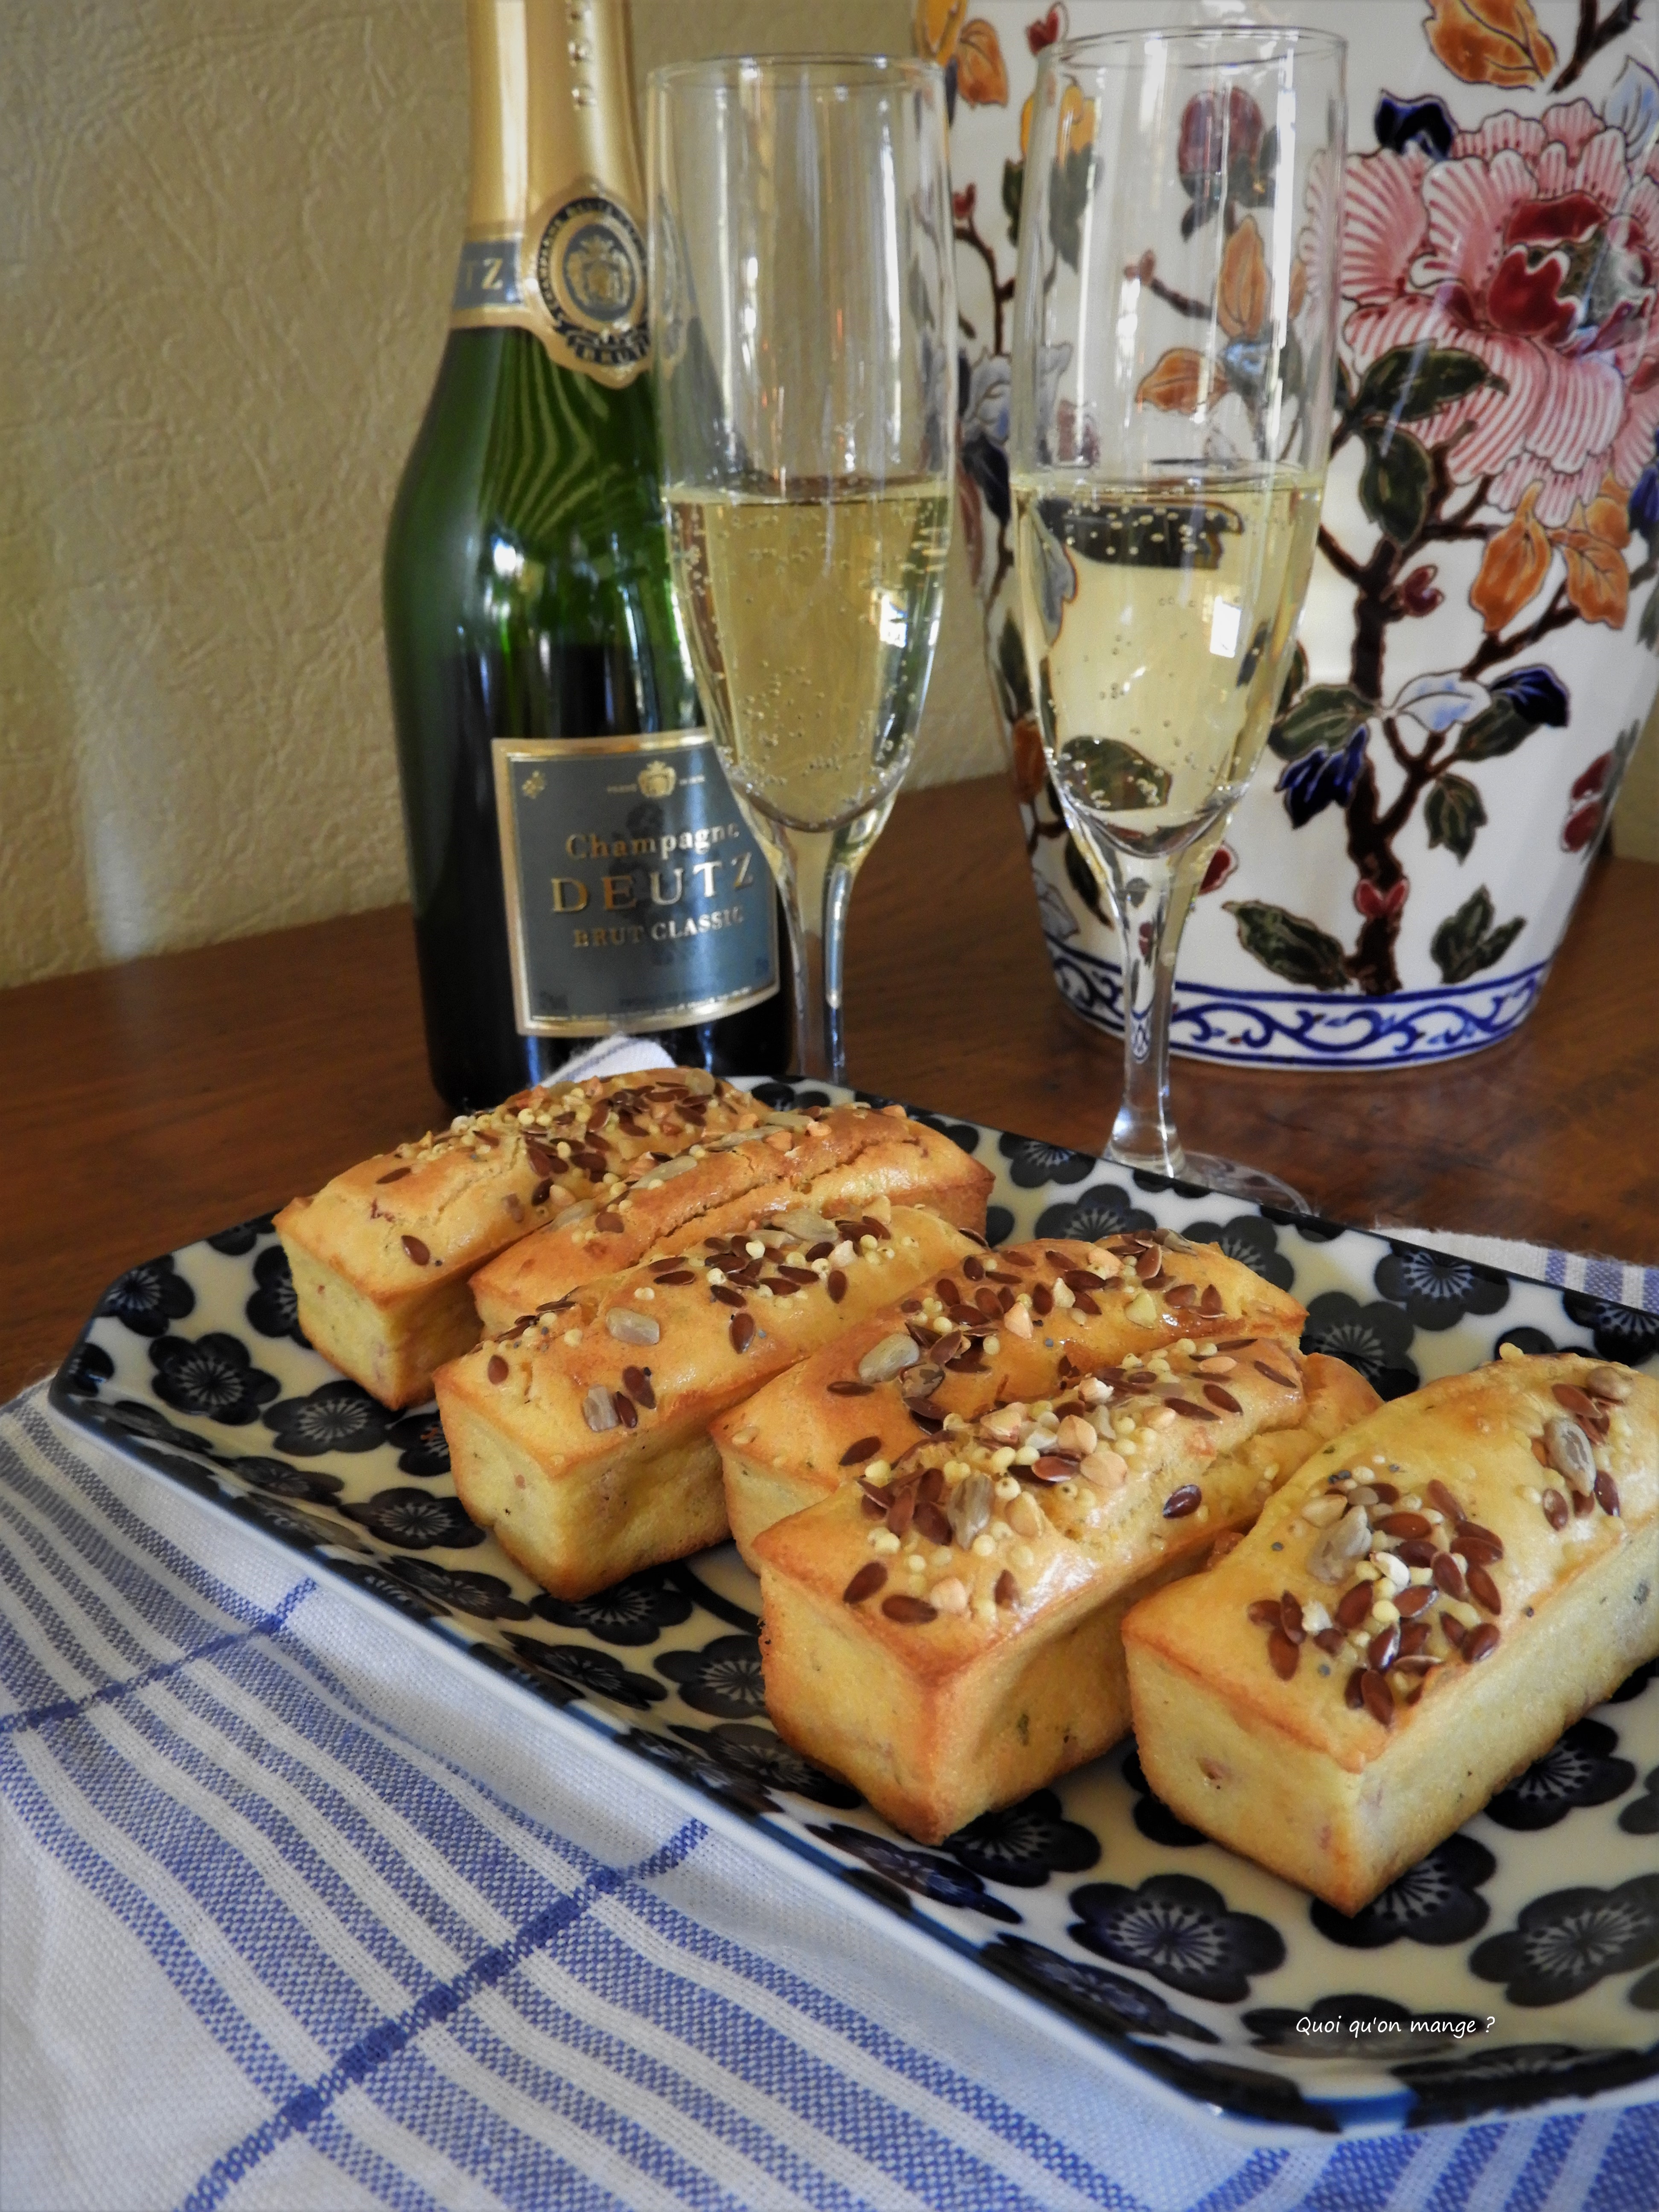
<box><xmin>0</xmin><ymin>0</ymin><xmax>998</xmax><ymax>984</ymax></box>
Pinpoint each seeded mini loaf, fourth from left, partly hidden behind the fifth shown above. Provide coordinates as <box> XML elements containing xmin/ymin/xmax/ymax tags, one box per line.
<box><xmin>714</xmin><ymin>1232</ymin><xmax>1307</xmax><ymax>1566</ymax></box>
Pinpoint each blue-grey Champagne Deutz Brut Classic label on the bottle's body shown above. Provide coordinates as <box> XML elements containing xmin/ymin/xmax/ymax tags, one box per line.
<box><xmin>493</xmin><ymin>730</ymin><xmax>779</xmax><ymax>1037</ymax></box>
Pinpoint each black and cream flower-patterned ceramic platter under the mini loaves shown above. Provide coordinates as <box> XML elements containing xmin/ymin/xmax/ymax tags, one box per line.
<box><xmin>53</xmin><ymin>1084</ymin><xmax>1659</xmax><ymax>2130</ymax></box>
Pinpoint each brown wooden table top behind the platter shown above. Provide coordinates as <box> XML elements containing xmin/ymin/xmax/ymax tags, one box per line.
<box><xmin>0</xmin><ymin>779</ymin><xmax>1659</xmax><ymax>1400</ymax></box>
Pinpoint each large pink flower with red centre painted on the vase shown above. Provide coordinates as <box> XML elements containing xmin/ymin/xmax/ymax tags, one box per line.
<box><xmin>1343</xmin><ymin>99</ymin><xmax>1659</xmax><ymax>531</ymax></box>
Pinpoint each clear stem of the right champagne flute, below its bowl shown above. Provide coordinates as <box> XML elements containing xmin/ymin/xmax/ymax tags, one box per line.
<box><xmin>1102</xmin><ymin>845</ymin><xmax>1197</xmax><ymax>1175</ymax></box>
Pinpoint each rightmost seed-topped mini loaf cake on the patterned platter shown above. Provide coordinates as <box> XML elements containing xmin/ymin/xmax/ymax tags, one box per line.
<box><xmin>1123</xmin><ymin>1354</ymin><xmax>1659</xmax><ymax>1913</ymax></box>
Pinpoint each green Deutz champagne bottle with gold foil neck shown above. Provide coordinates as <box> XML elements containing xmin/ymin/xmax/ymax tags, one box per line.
<box><xmin>385</xmin><ymin>0</ymin><xmax>788</xmax><ymax>1110</ymax></box>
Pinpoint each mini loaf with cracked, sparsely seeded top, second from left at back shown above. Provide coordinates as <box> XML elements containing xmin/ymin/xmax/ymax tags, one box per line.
<box><xmin>473</xmin><ymin>1106</ymin><xmax>993</xmax><ymax>1334</ymax></box>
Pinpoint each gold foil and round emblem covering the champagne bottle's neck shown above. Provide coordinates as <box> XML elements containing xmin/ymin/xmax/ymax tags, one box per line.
<box><xmin>451</xmin><ymin>0</ymin><xmax>650</xmax><ymax>385</ymax></box>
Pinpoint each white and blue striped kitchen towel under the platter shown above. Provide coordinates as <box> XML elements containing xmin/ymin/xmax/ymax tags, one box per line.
<box><xmin>0</xmin><ymin>1391</ymin><xmax>1659</xmax><ymax>2212</ymax></box>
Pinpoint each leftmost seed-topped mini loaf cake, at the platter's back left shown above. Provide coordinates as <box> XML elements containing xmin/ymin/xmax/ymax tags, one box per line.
<box><xmin>276</xmin><ymin>1068</ymin><xmax>778</xmax><ymax>1407</ymax></box>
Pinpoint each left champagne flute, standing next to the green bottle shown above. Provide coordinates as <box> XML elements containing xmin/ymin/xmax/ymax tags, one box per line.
<box><xmin>648</xmin><ymin>55</ymin><xmax>955</xmax><ymax>1080</ymax></box>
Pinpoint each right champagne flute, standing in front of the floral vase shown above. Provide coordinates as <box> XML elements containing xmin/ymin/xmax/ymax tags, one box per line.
<box><xmin>1011</xmin><ymin>24</ymin><xmax>1345</xmax><ymax>1205</ymax></box>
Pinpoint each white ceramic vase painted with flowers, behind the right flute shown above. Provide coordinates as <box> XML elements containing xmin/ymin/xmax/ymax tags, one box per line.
<box><xmin>916</xmin><ymin>0</ymin><xmax>1659</xmax><ymax>1068</ymax></box>
